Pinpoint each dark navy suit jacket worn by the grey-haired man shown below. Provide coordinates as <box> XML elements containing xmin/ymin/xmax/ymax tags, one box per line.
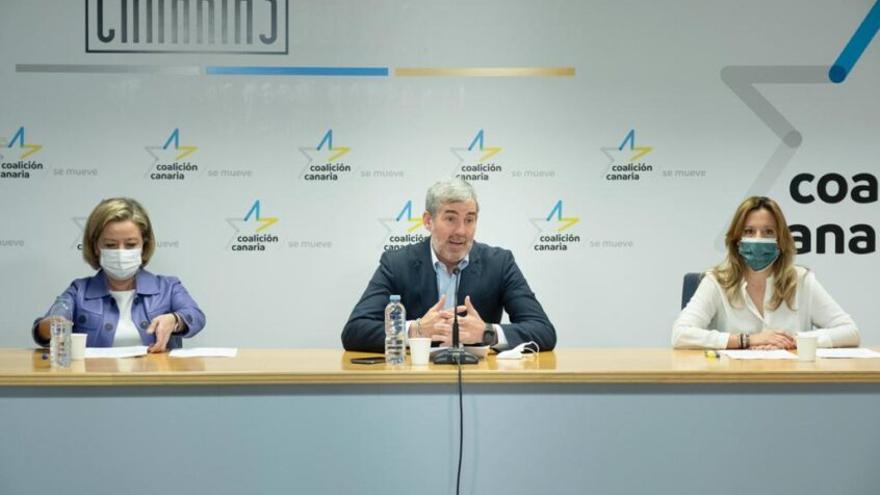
<box><xmin>342</xmin><ymin>238</ymin><xmax>556</xmax><ymax>352</ymax></box>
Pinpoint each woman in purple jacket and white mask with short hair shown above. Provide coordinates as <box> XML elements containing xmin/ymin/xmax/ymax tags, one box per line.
<box><xmin>33</xmin><ymin>198</ymin><xmax>205</xmax><ymax>352</ymax></box>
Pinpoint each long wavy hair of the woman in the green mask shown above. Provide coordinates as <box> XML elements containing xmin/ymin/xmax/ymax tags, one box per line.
<box><xmin>712</xmin><ymin>196</ymin><xmax>797</xmax><ymax>310</ymax></box>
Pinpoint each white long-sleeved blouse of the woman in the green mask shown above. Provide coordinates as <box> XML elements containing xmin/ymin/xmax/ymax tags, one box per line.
<box><xmin>672</xmin><ymin>266</ymin><xmax>859</xmax><ymax>349</ymax></box>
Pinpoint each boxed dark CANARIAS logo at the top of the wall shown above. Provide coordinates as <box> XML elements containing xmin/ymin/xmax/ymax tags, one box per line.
<box><xmin>85</xmin><ymin>0</ymin><xmax>289</xmax><ymax>55</ymax></box>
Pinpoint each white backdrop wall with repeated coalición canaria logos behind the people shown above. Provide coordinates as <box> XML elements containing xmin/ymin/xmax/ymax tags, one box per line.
<box><xmin>0</xmin><ymin>0</ymin><xmax>880</xmax><ymax>347</ymax></box>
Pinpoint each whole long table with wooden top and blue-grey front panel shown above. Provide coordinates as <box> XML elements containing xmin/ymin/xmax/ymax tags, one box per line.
<box><xmin>0</xmin><ymin>348</ymin><xmax>880</xmax><ymax>495</ymax></box>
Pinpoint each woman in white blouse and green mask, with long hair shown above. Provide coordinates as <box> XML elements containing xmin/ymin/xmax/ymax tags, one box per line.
<box><xmin>672</xmin><ymin>196</ymin><xmax>859</xmax><ymax>349</ymax></box>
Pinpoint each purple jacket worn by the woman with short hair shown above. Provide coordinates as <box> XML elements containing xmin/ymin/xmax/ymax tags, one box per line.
<box><xmin>32</xmin><ymin>269</ymin><xmax>205</xmax><ymax>349</ymax></box>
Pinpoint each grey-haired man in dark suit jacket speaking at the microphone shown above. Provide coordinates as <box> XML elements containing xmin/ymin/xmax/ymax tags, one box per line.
<box><xmin>342</xmin><ymin>179</ymin><xmax>556</xmax><ymax>352</ymax></box>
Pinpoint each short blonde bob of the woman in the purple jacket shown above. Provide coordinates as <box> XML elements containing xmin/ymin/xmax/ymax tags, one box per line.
<box><xmin>83</xmin><ymin>198</ymin><xmax>156</xmax><ymax>270</ymax></box>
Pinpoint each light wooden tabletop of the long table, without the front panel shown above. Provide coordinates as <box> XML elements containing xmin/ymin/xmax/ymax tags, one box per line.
<box><xmin>0</xmin><ymin>348</ymin><xmax>880</xmax><ymax>386</ymax></box>
